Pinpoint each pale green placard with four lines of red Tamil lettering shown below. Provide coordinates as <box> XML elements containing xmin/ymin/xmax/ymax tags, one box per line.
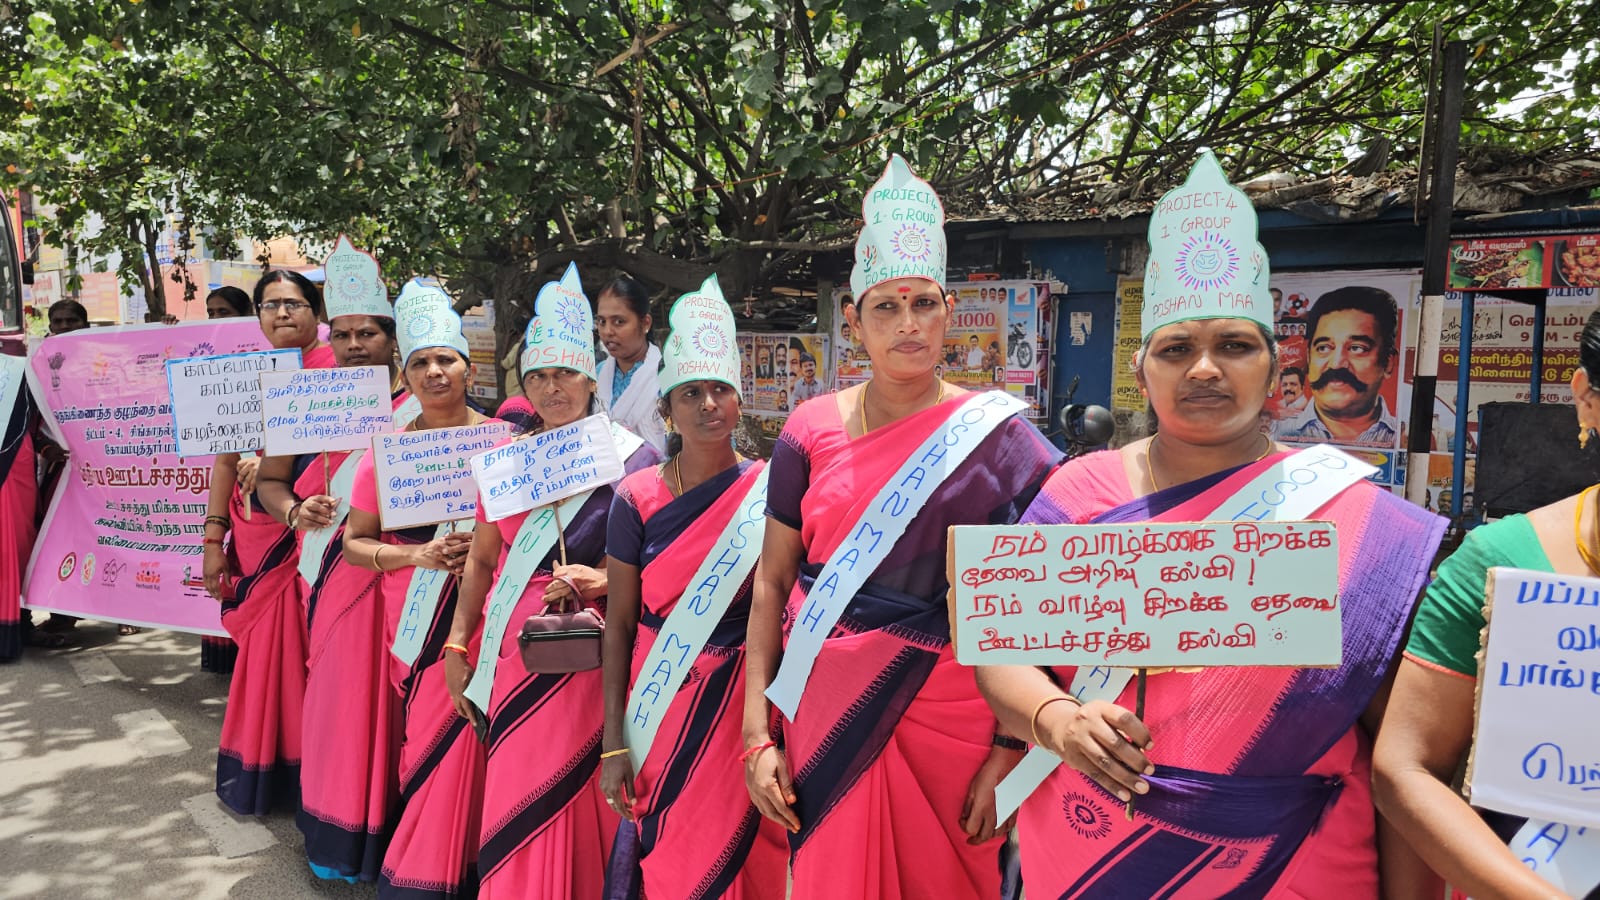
<box><xmin>949</xmin><ymin>522</ymin><xmax>1342</xmax><ymax>666</ymax></box>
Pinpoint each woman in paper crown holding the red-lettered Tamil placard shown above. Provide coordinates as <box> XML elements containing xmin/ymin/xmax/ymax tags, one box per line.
<box><xmin>978</xmin><ymin>152</ymin><xmax>1443</xmax><ymax>898</ymax></box>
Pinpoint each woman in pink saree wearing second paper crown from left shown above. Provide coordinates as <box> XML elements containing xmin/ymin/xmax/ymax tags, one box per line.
<box><xmin>344</xmin><ymin>280</ymin><xmax>486</xmax><ymax>900</ymax></box>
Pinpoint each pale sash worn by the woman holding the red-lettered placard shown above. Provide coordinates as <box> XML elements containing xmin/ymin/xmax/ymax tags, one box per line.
<box><xmin>995</xmin><ymin>444</ymin><xmax>1378</xmax><ymax>822</ymax></box>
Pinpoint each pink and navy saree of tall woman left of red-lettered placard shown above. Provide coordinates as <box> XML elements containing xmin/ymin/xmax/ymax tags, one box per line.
<box><xmin>768</xmin><ymin>394</ymin><xmax>1061</xmax><ymax>900</ymax></box>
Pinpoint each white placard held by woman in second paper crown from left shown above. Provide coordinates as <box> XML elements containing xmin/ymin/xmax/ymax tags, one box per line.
<box><xmin>371</xmin><ymin>421</ymin><xmax>512</xmax><ymax>532</ymax></box>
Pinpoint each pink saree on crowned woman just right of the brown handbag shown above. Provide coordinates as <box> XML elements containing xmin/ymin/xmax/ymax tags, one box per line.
<box><xmin>606</xmin><ymin>461</ymin><xmax>787</xmax><ymax>900</ymax></box>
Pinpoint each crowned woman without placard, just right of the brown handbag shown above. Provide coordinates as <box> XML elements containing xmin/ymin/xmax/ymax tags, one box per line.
<box><xmin>600</xmin><ymin>275</ymin><xmax>787</xmax><ymax>900</ymax></box>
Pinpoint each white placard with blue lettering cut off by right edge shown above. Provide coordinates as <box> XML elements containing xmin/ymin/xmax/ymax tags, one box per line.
<box><xmin>1466</xmin><ymin>567</ymin><xmax>1600</xmax><ymax>826</ymax></box>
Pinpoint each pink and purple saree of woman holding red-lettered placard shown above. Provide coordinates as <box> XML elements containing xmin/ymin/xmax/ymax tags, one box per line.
<box><xmin>1019</xmin><ymin>452</ymin><xmax>1445</xmax><ymax>900</ymax></box>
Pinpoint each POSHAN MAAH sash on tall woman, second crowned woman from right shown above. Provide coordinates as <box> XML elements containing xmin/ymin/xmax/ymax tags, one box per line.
<box><xmin>766</xmin><ymin>391</ymin><xmax>1027</xmax><ymax>719</ymax></box>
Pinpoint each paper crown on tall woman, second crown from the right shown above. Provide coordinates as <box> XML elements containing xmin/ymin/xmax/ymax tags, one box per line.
<box><xmin>850</xmin><ymin>154</ymin><xmax>949</xmax><ymax>299</ymax></box>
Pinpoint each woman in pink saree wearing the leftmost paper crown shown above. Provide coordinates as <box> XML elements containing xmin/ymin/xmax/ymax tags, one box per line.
<box><xmin>258</xmin><ymin>235</ymin><xmax>414</xmax><ymax>881</ymax></box>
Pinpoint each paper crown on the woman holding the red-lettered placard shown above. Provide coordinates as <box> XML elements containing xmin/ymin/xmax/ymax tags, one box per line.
<box><xmin>1139</xmin><ymin>149</ymin><xmax>1272</xmax><ymax>340</ymax></box>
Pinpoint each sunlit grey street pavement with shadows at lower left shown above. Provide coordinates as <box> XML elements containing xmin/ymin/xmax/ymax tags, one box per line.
<box><xmin>0</xmin><ymin>617</ymin><xmax>376</xmax><ymax>900</ymax></box>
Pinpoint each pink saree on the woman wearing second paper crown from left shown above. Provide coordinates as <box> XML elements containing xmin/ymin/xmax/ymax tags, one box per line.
<box><xmin>350</xmin><ymin>453</ymin><xmax>483</xmax><ymax>900</ymax></box>
